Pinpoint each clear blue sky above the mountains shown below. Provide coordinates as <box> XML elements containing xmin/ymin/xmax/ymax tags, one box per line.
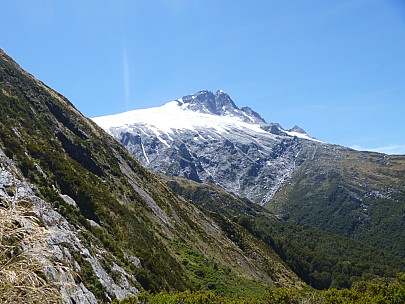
<box><xmin>0</xmin><ymin>0</ymin><xmax>405</xmax><ymax>154</ymax></box>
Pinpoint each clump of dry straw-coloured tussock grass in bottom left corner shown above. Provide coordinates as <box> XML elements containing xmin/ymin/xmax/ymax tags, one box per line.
<box><xmin>0</xmin><ymin>199</ymin><xmax>62</xmax><ymax>303</ymax></box>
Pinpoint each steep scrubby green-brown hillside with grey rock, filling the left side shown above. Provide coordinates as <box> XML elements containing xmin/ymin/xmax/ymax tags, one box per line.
<box><xmin>0</xmin><ymin>51</ymin><xmax>302</xmax><ymax>303</ymax></box>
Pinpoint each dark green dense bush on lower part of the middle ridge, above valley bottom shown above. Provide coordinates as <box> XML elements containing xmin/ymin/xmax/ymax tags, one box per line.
<box><xmin>235</xmin><ymin>216</ymin><xmax>404</xmax><ymax>289</ymax></box>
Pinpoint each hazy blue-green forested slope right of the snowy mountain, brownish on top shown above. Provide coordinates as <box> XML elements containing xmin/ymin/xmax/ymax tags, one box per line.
<box><xmin>266</xmin><ymin>145</ymin><xmax>405</xmax><ymax>258</ymax></box>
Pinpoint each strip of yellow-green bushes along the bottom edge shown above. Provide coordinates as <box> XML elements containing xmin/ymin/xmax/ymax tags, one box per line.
<box><xmin>113</xmin><ymin>273</ymin><xmax>405</xmax><ymax>304</ymax></box>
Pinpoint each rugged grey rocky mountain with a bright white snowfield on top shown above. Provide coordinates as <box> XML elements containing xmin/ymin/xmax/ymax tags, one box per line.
<box><xmin>93</xmin><ymin>91</ymin><xmax>321</xmax><ymax>204</ymax></box>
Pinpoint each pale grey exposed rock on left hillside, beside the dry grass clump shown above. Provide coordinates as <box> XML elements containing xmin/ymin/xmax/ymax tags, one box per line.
<box><xmin>0</xmin><ymin>149</ymin><xmax>138</xmax><ymax>304</ymax></box>
